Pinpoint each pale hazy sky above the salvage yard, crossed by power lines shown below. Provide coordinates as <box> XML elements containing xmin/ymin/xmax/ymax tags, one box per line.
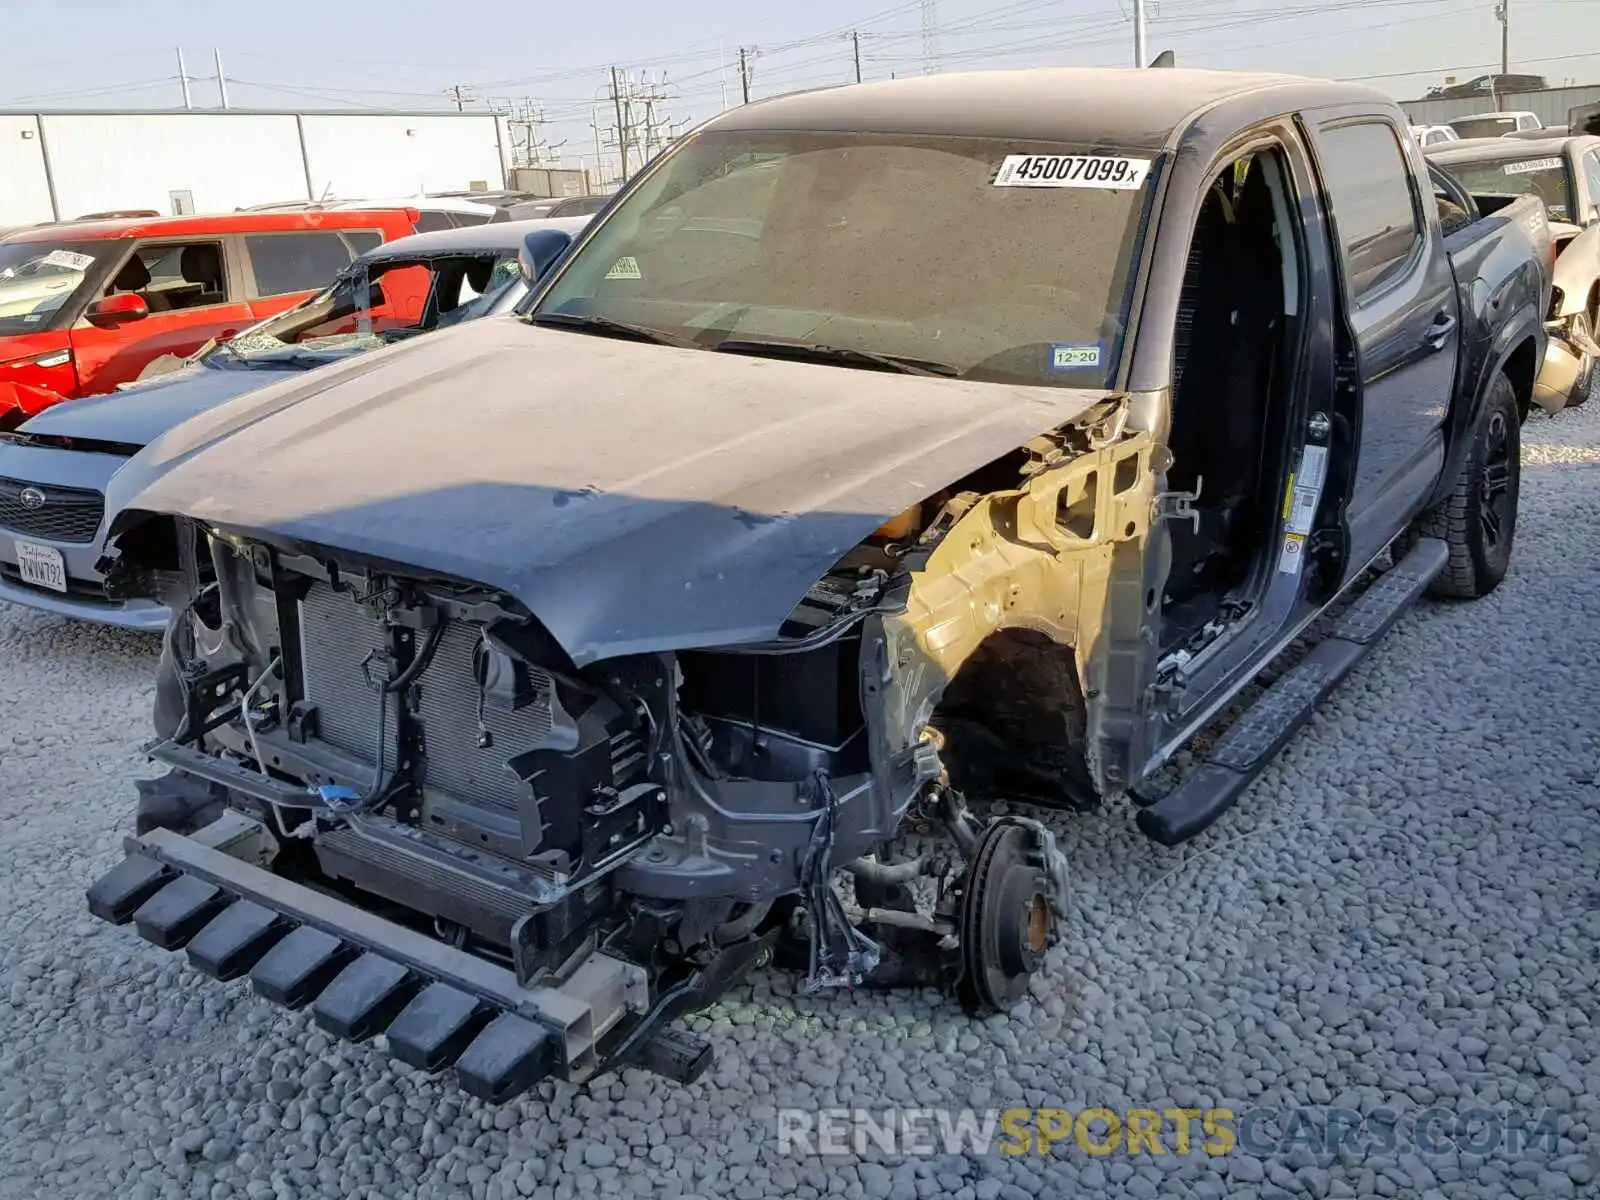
<box><xmin>0</xmin><ymin>0</ymin><xmax>1600</xmax><ymax>176</ymax></box>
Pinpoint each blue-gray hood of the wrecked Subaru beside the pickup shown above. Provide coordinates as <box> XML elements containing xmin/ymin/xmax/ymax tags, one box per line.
<box><xmin>21</xmin><ymin>366</ymin><xmax>294</xmax><ymax>446</ymax></box>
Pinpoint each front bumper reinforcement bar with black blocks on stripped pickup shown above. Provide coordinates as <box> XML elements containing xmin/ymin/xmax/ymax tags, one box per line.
<box><xmin>86</xmin><ymin>814</ymin><xmax>650</xmax><ymax>1104</ymax></box>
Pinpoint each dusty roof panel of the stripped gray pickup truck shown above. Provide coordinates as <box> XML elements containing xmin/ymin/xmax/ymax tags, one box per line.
<box><xmin>704</xmin><ymin>67</ymin><xmax>1394</xmax><ymax>150</ymax></box>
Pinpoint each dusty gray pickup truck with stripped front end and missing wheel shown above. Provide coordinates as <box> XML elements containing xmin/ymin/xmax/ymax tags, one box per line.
<box><xmin>88</xmin><ymin>63</ymin><xmax>1550</xmax><ymax>1101</ymax></box>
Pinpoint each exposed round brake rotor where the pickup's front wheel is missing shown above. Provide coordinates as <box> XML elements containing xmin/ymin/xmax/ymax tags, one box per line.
<box><xmin>955</xmin><ymin>822</ymin><xmax>1054</xmax><ymax>1016</ymax></box>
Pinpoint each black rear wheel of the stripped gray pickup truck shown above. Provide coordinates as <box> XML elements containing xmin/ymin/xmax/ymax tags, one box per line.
<box><xmin>1397</xmin><ymin>374</ymin><xmax>1522</xmax><ymax>600</ymax></box>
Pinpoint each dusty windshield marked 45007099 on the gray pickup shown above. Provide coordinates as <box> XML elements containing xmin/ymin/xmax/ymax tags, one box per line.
<box><xmin>530</xmin><ymin>131</ymin><xmax>1154</xmax><ymax>387</ymax></box>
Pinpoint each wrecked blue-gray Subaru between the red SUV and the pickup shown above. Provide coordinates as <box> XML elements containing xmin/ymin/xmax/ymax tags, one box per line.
<box><xmin>0</xmin><ymin>218</ymin><xmax>587</xmax><ymax>630</ymax></box>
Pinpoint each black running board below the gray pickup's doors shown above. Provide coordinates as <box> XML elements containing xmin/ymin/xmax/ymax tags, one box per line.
<box><xmin>1134</xmin><ymin>538</ymin><xmax>1450</xmax><ymax>846</ymax></box>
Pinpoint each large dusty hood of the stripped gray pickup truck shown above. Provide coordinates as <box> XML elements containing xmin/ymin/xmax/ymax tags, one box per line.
<box><xmin>107</xmin><ymin>320</ymin><xmax>1106</xmax><ymax>666</ymax></box>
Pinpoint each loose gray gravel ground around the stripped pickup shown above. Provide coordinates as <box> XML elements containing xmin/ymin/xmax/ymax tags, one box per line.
<box><xmin>0</xmin><ymin>403</ymin><xmax>1600</xmax><ymax>1200</ymax></box>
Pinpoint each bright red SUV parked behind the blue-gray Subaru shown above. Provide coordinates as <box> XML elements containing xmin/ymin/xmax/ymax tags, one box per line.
<box><xmin>0</xmin><ymin>208</ymin><xmax>418</xmax><ymax>429</ymax></box>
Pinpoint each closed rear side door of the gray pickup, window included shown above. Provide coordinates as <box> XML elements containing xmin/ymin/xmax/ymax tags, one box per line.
<box><xmin>1314</xmin><ymin>110</ymin><xmax>1458</xmax><ymax>562</ymax></box>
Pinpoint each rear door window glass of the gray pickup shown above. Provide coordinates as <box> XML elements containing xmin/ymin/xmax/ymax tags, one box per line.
<box><xmin>1317</xmin><ymin>122</ymin><xmax>1422</xmax><ymax>304</ymax></box>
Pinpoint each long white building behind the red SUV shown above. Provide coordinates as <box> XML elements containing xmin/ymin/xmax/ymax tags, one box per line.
<box><xmin>0</xmin><ymin>109</ymin><xmax>507</xmax><ymax>227</ymax></box>
